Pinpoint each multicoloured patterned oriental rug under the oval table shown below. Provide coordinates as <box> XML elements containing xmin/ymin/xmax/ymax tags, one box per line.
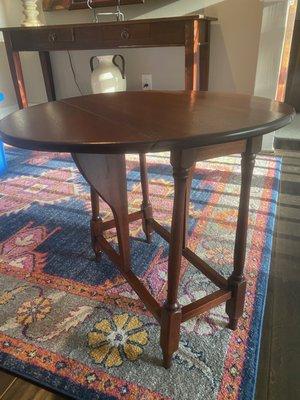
<box><xmin>0</xmin><ymin>147</ymin><xmax>280</xmax><ymax>400</ymax></box>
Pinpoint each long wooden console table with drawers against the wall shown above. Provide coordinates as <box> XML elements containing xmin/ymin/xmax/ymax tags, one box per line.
<box><xmin>0</xmin><ymin>15</ymin><xmax>215</xmax><ymax>108</ymax></box>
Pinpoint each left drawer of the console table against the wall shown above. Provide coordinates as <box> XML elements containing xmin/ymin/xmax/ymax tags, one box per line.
<box><xmin>11</xmin><ymin>28</ymin><xmax>75</xmax><ymax>50</ymax></box>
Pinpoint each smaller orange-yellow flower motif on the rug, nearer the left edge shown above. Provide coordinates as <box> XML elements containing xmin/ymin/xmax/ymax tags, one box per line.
<box><xmin>16</xmin><ymin>296</ymin><xmax>51</xmax><ymax>325</ymax></box>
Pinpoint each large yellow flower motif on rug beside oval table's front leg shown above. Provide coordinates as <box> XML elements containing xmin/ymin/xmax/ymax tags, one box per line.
<box><xmin>88</xmin><ymin>314</ymin><xmax>149</xmax><ymax>368</ymax></box>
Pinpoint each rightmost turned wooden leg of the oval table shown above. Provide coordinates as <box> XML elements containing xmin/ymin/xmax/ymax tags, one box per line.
<box><xmin>226</xmin><ymin>140</ymin><xmax>255</xmax><ymax>330</ymax></box>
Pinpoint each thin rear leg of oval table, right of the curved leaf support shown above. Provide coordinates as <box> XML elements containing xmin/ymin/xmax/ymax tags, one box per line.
<box><xmin>139</xmin><ymin>154</ymin><xmax>153</xmax><ymax>243</ymax></box>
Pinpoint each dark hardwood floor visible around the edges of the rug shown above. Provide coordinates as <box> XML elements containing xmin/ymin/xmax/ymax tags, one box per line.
<box><xmin>0</xmin><ymin>152</ymin><xmax>300</xmax><ymax>400</ymax></box>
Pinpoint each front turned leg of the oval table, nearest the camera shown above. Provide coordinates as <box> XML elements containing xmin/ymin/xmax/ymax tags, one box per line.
<box><xmin>160</xmin><ymin>151</ymin><xmax>195</xmax><ymax>368</ymax></box>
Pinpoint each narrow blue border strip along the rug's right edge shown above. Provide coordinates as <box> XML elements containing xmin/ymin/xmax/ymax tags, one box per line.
<box><xmin>238</xmin><ymin>157</ymin><xmax>282</xmax><ymax>400</ymax></box>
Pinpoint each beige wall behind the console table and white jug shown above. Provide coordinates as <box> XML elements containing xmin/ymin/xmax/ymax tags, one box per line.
<box><xmin>0</xmin><ymin>0</ymin><xmax>262</xmax><ymax>105</ymax></box>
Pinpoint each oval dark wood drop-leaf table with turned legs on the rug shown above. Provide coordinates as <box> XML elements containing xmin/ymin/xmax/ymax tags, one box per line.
<box><xmin>0</xmin><ymin>91</ymin><xmax>294</xmax><ymax>368</ymax></box>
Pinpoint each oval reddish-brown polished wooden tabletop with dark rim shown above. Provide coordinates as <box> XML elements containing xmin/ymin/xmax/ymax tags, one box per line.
<box><xmin>0</xmin><ymin>91</ymin><xmax>294</xmax><ymax>153</ymax></box>
